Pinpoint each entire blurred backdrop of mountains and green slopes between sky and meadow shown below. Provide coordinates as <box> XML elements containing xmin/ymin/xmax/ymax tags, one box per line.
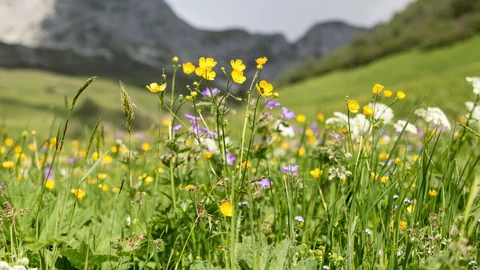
<box><xmin>0</xmin><ymin>0</ymin><xmax>480</xmax><ymax>132</ymax></box>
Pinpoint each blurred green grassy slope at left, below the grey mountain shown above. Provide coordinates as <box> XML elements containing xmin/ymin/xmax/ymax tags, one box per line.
<box><xmin>0</xmin><ymin>69</ymin><xmax>165</xmax><ymax>131</ymax></box>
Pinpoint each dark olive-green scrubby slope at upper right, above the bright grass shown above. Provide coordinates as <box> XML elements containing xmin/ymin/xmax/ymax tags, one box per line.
<box><xmin>278</xmin><ymin>0</ymin><xmax>480</xmax><ymax>84</ymax></box>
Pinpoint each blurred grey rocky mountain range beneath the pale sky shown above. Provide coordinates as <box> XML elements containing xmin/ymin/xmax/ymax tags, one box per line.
<box><xmin>0</xmin><ymin>0</ymin><xmax>366</xmax><ymax>84</ymax></box>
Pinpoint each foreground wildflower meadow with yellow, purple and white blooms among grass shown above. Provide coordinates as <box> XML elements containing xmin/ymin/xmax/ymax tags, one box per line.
<box><xmin>0</xmin><ymin>57</ymin><xmax>480</xmax><ymax>270</ymax></box>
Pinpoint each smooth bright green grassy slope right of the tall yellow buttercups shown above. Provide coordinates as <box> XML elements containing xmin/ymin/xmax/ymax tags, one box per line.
<box><xmin>281</xmin><ymin>34</ymin><xmax>480</xmax><ymax>118</ymax></box>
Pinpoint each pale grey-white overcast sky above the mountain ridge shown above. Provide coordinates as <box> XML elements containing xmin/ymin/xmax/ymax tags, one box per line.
<box><xmin>166</xmin><ymin>0</ymin><xmax>413</xmax><ymax>41</ymax></box>
